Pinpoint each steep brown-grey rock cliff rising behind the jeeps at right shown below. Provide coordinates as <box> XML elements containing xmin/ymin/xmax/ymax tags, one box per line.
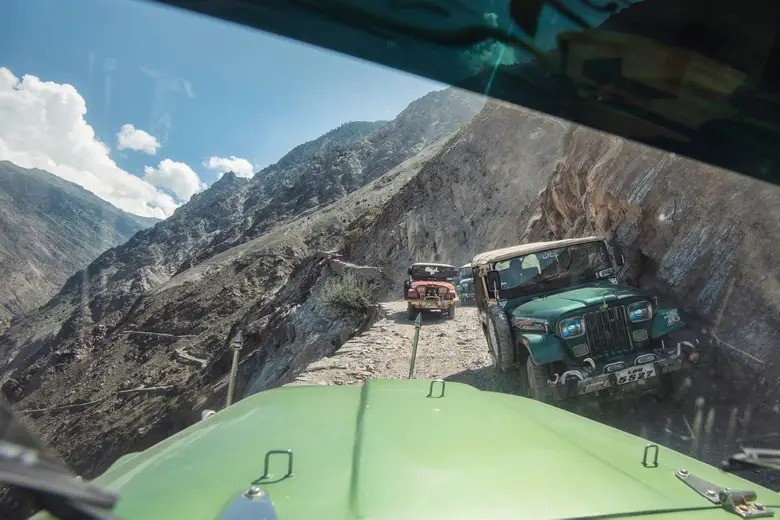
<box><xmin>352</xmin><ymin>99</ymin><xmax>780</xmax><ymax>398</ymax></box>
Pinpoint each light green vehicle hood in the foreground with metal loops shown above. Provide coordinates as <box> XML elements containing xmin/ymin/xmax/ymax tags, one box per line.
<box><xmin>38</xmin><ymin>380</ymin><xmax>780</xmax><ymax>520</ymax></box>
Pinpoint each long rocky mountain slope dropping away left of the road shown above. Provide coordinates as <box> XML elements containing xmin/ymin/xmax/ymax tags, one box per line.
<box><xmin>0</xmin><ymin>90</ymin><xmax>484</xmax><ymax>475</ymax></box>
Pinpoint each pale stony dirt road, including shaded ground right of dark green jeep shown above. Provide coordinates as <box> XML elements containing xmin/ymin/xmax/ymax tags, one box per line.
<box><xmin>290</xmin><ymin>301</ymin><xmax>780</xmax><ymax>489</ymax></box>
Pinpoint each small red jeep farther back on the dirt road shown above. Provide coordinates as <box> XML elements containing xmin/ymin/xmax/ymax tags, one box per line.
<box><xmin>404</xmin><ymin>263</ymin><xmax>458</xmax><ymax>320</ymax></box>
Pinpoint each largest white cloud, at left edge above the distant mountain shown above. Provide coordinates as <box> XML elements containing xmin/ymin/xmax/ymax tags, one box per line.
<box><xmin>0</xmin><ymin>67</ymin><xmax>177</xmax><ymax>218</ymax></box>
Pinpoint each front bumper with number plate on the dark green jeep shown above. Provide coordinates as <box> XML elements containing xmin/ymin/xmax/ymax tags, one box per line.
<box><xmin>548</xmin><ymin>351</ymin><xmax>693</xmax><ymax>401</ymax></box>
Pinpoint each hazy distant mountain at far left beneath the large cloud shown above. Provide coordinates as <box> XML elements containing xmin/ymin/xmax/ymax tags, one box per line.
<box><xmin>0</xmin><ymin>161</ymin><xmax>157</xmax><ymax>330</ymax></box>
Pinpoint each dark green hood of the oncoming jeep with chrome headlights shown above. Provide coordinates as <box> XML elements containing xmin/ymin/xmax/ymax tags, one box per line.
<box><xmin>507</xmin><ymin>281</ymin><xmax>648</xmax><ymax>322</ymax></box>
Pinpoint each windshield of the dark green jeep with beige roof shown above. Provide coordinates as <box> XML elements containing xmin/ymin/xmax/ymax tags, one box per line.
<box><xmin>495</xmin><ymin>242</ymin><xmax>613</xmax><ymax>294</ymax></box>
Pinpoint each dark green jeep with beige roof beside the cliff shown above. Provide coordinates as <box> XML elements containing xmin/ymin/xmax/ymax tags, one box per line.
<box><xmin>472</xmin><ymin>237</ymin><xmax>699</xmax><ymax>401</ymax></box>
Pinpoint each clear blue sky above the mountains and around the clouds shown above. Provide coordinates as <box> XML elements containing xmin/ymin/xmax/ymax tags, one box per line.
<box><xmin>0</xmin><ymin>0</ymin><xmax>442</xmax><ymax>216</ymax></box>
